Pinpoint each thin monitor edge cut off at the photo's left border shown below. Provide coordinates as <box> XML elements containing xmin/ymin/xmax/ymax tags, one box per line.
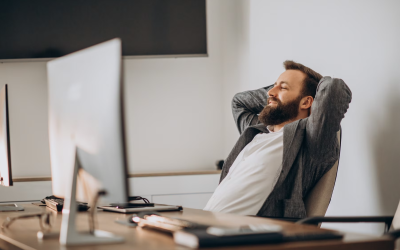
<box><xmin>0</xmin><ymin>84</ymin><xmax>13</xmax><ymax>187</ymax></box>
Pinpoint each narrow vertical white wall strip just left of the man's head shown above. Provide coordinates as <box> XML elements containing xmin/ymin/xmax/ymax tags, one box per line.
<box><xmin>221</xmin><ymin>0</ymin><xmax>250</xmax><ymax>158</ymax></box>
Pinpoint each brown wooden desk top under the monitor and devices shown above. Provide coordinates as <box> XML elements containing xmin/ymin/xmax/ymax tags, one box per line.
<box><xmin>0</xmin><ymin>204</ymin><xmax>394</xmax><ymax>250</ymax></box>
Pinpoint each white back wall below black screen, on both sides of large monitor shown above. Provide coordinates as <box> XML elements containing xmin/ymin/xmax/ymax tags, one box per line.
<box><xmin>0</xmin><ymin>1</ymin><xmax>224</xmax><ymax>177</ymax></box>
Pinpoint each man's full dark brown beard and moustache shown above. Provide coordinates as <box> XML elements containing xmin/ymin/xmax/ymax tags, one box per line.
<box><xmin>258</xmin><ymin>96</ymin><xmax>302</xmax><ymax>126</ymax></box>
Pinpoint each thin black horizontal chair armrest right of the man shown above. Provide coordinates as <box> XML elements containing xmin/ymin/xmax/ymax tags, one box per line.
<box><xmin>296</xmin><ymin>216</ymin><xmax>394</xmax><ymax>233</ymax></box>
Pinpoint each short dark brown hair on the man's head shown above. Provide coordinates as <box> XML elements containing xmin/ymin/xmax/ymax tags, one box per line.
<box><xmin>283</xmin><ymin>60</ymin><xmax>322</xmax><ymax>98</ymax></box>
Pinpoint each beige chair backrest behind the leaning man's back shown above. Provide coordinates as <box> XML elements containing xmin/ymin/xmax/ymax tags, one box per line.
<box><xmin>304</xmin><ymin>130</ymin><xmax>341</xmax><ymax>217</ymax></box>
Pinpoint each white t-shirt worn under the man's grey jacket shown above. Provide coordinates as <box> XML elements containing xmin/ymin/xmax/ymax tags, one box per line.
<box><xmin>204</xmin><ymin>127</ymin><xmax>283</xmax><ymax>215</ymax></box>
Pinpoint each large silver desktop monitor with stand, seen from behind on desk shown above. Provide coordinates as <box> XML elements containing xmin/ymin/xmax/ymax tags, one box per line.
<box><xmin>47</xmin><ymin>39</ymin><xmax>128</xmax><ymax>245</ymax></box>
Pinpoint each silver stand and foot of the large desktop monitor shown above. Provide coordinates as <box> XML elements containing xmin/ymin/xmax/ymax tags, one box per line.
<box><xmin>60</xmin><ymin>148</ymin><xmax>125</xmax><ymax>246</ymax></box>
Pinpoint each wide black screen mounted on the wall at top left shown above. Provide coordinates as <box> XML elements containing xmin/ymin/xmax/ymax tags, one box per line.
<box><xmin>0</xmin><ymin>0</ymin><xmax>207</xmax><ymax>59</ymax></box>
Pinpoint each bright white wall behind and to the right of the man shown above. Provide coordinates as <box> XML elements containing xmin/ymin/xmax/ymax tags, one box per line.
<box><xmin>224</xmin><ymin>0</ymin><xmax>400</xmax><ymax>233</ymax></box>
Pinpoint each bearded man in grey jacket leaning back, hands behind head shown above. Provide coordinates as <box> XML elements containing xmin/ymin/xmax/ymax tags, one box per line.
<box><xmin>204</xmin><ymin>61</ymin><xmax>351</xmax><ymax>218</ymax></box>
